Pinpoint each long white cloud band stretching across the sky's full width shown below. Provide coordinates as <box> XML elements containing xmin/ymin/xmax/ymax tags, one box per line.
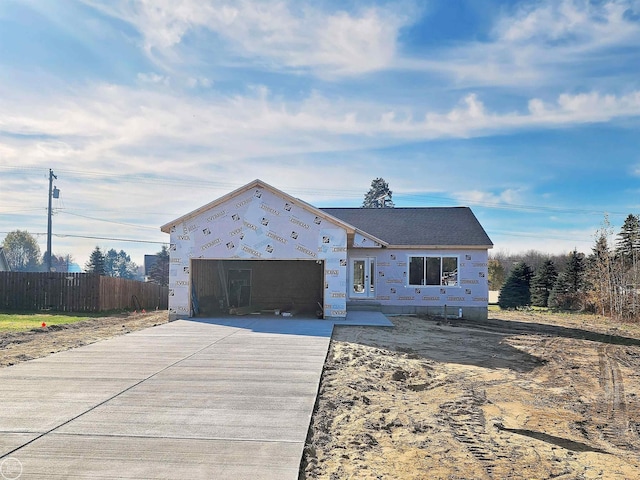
<box><xmin>0</xmin><ymin>85</ymin><xmax>640</xmax><ymax>174</ymax></box>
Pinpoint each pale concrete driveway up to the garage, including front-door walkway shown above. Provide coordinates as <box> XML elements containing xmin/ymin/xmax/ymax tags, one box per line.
<box><xmin>0</xmin><ymin>312</ymin><xmax>391</xmax><ymax>480</ymax></box>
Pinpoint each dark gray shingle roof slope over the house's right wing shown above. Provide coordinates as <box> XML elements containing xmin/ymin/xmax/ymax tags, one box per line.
<box><xmin>320</xmin><ymin>207</ymin><xmax>493</xmax><ymax>247</ymax></box>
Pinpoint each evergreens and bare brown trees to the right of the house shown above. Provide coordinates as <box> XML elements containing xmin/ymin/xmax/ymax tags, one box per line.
<box><xmin>498</xmin><ymin>214</ymin><xmax>640</xmax><ymax>321</ymax></box>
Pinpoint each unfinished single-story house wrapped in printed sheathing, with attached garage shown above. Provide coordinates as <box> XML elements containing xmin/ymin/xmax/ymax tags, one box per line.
<box><xmin>161</xmin><ymin>180</ymin><xmax>493</xmax><ymax>318</ymax></box>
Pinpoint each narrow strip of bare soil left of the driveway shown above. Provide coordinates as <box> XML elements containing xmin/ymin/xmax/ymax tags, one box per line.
<box><xmin>0</xmin><ymin>311</ymin><xmax>169</xmax><ymax>367</ymax></box>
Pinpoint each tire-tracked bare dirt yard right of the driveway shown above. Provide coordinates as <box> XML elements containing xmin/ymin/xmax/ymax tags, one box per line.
<box><xmin>300</xmin><ymin>312</ymin><xmax>640</xmax><ymax>480</ymax></box>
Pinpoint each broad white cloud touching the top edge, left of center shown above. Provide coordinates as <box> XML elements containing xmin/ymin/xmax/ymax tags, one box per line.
<box><xmin>85</xmin><ymin>0</ymin><xmax>415</xmax><ymax>75</ymax></box>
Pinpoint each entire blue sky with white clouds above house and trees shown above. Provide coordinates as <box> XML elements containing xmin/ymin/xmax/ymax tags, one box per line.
<box><xmin>0</xmin><ymin>0</ymin><xmax>640</xmax><ymax>265</ymax></box>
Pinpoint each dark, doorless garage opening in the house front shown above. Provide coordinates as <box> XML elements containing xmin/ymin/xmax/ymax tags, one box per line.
<box><xmin>191</xmin><ymin>259</ymin><xmax>324</xmax><ymax>316</ymax></box>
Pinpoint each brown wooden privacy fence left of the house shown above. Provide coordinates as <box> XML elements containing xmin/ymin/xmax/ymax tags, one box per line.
<box><xmin>0</xmin><ymin>272</ymin><xmax>169</xmax><ymax>312</ymax></box>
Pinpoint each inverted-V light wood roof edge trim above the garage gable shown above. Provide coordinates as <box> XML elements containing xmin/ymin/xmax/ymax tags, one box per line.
<box><xmin>160</xmin><ymin>179</ymin><xmax>386</xmax><ymax>245</ymax></box>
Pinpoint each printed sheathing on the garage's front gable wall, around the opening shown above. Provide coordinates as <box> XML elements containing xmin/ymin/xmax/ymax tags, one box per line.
<box><xmin>169</xmin><ymin>187</ymin><xmax>347</xmax><ymax>319</ymax></box>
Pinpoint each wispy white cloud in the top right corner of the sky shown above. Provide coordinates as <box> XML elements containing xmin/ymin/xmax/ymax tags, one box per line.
<box><xmin>395</xmin><ymin>0</ymin><xmax>640</xmax><ymax>88</ymax></box>
